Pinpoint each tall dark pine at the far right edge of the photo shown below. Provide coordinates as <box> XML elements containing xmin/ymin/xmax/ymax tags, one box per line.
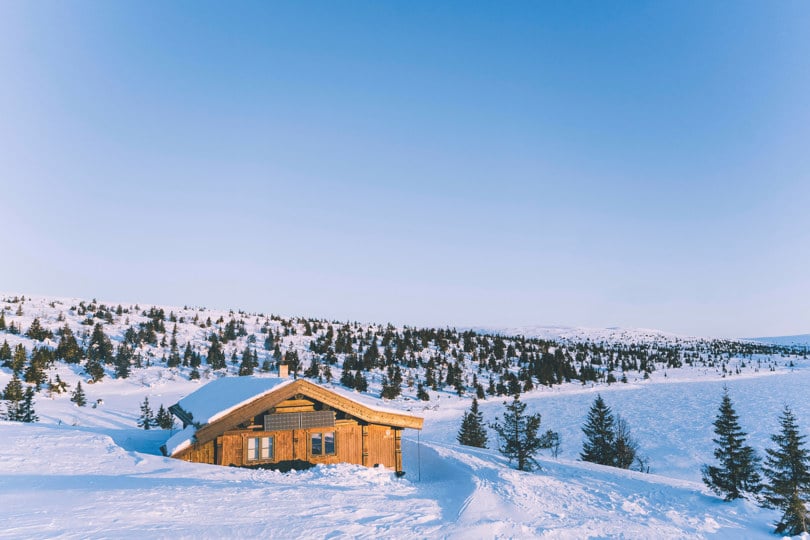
<box><xmin>763</xmin><ymin>406</ymin><xmax>810</xmax><ymax>536</ymax></box>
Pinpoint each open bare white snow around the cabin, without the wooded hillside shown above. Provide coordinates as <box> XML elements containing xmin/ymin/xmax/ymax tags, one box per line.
<box><xmin>0</xmin><ymin>294</ymin><xmax>810</xmax><ymax>539</ymax></box>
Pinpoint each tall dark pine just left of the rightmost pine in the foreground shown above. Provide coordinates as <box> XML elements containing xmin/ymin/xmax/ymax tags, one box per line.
<box><xmin>702</xmin><ymin>389</ymin><xmax>761</xmax><ymax>501</ymax></box>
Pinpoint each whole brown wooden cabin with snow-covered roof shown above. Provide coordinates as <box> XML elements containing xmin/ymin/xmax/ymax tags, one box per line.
<box><xmin>162</xmin><ymin>377</ymin><xmax>423</xmax><ymax>474</ymax></box>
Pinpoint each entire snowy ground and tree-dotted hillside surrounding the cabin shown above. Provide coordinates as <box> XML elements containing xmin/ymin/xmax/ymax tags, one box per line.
<box><xmin>0</xmin><ymin>295</ymin><xmax>810</xmax><ymax>539</ymax></box>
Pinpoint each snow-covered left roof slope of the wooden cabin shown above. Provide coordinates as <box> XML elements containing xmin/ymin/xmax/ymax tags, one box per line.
<box><xmin>177</xmin><ymin>377</ymin><xmax>293</xmax><ymax>425</ymax></box>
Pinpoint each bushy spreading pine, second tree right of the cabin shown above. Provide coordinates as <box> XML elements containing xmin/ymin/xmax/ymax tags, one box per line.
<box><xmin>492</xmin><ymin>394</ymin><xmax>551</xmax><ymax>471</ymax></box>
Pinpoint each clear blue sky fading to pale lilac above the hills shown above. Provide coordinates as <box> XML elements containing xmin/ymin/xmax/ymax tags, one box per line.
<box><xmin>0</xmin><ymin>1</ymin><xmax>810</xmax><ymax>336</ymax></box>
